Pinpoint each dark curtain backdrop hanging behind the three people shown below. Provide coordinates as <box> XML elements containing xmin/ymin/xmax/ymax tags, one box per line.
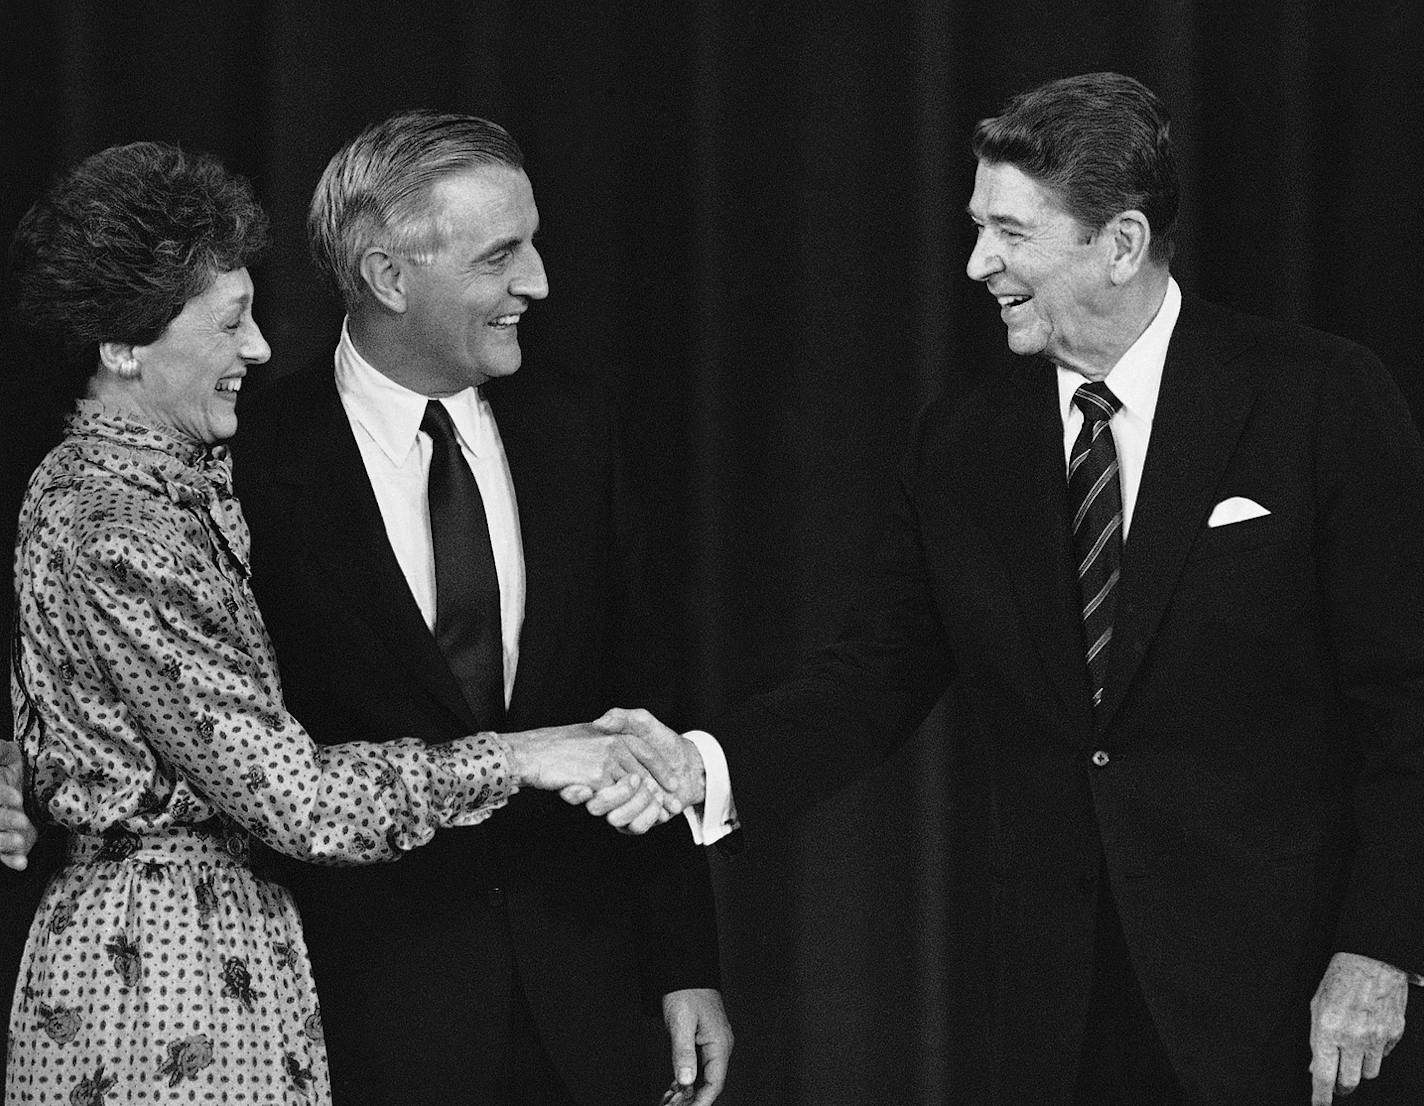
<box><xmin>0</xmin><ymin>0</ymin><xmax>1424</xmax><ymax>1106</ymax></box>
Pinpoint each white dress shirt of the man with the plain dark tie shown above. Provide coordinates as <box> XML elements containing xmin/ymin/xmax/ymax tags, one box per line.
<box><xmin>336</xmin><ymin>322</ymin><xmax>524</xmax><ymax>706</ymax></box>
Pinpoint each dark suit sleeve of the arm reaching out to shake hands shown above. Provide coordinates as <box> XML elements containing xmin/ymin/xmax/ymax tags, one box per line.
<box><xmin>712</xmin><ymin>404</ymin><xmax>954</xmax><ymax>827</ymax></box>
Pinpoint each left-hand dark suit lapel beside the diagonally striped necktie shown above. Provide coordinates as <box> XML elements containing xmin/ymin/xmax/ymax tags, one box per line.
<box><xmin>981</xmin><ymin>359</ymin><xmax>1092</xmax><ymax>733</ymax></box>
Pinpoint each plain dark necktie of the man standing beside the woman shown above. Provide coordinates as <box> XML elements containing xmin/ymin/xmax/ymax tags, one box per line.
<box><xmin>420</xmin><ymin>400</ymin><xmax>504</xmax><ymax>730</ymax></box>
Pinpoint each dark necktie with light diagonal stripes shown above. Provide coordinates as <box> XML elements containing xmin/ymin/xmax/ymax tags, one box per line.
<box><xmin>1068</xmin><ymin>380</ymin><xmax>1122</xmax><ymax>706</ymax></box>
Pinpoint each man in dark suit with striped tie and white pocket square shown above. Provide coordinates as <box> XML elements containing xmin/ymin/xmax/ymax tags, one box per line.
<box><xmin>606</xmin><ymin>74</ymin><xmax>1424</xmax><ymax>1106</ymax></box>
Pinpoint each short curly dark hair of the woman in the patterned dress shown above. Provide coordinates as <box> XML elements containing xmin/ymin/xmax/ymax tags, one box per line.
<box><xmin>7</xmin><ymin>142</ymin><xmax>269</xmax><ymax>400</ymax></box>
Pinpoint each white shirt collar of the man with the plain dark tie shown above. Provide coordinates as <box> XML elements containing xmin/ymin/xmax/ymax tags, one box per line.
<box><xmin>336</xmin><ymin>320</ymin><xmax>497</xmax><ymax>467</ymax></box>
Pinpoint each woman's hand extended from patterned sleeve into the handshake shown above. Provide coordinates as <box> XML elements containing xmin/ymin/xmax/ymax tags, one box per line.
<box><xmin>500</xmin><ymin>719</ymin><xmax>679</xmax><ymax>797</ymax></box>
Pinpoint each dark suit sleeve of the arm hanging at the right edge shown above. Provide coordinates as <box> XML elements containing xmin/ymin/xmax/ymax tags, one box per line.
<box><xmin>1316</xmin><ymin>350</ymin><xmax>1424</xmax><ymax>972</ymax></box>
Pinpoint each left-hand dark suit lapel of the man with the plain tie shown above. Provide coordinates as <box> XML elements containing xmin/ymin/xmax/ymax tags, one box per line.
<box><xmin>298</xmin><ymin>369</ymin><xmax>474</xmax><ymax>730</ymax></box>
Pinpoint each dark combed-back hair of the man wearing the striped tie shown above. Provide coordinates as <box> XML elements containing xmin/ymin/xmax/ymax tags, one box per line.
<box><xmin>971</xmin><ymin>73</ymin><xmax>1180</xmax><ymax>263</ymax></box>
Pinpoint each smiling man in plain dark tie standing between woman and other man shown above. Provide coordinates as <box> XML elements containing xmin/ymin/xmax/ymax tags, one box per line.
<box><xmin>235</xmin><ymin>112</ymin><xmax>731</xmax><ymax>1106</ymax></box>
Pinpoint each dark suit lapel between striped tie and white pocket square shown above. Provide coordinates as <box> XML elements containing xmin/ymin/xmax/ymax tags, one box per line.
<box><xmin>1096</xmin><ymin>297</ymin><xmax>1256</xmax><ymax>729</ymax></box>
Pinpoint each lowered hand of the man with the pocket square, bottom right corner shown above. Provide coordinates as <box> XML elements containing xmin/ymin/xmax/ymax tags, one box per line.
<box><xmin>1310</xmin><ymin>952</ymin><xmax>1410</xmax><ymax>1106</ymax></box>
